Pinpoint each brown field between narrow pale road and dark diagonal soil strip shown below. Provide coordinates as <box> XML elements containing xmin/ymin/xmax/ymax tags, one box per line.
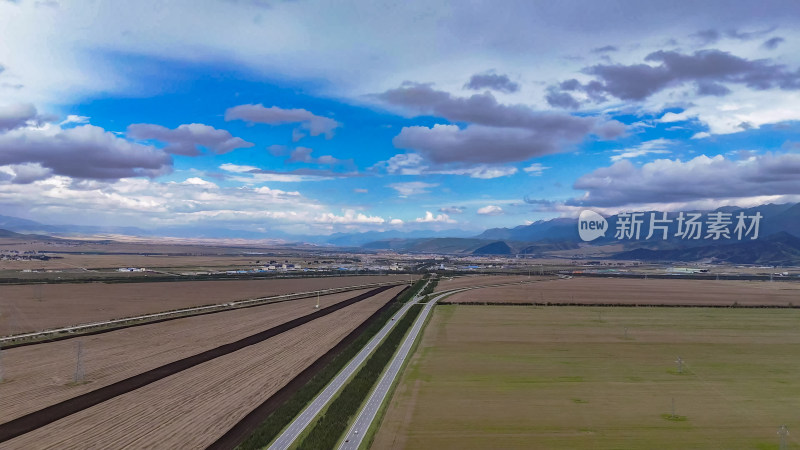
<box><xmin>0</xmin><ymin>288</ymin><xmax>400</xmax><ymax>422</ymax></box>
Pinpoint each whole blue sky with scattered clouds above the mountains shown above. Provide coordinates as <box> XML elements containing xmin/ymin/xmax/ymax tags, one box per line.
<box><xmin>0</xmin><ymin>0</ymin><xmax>800</xmax><ymax>235</ymax></box>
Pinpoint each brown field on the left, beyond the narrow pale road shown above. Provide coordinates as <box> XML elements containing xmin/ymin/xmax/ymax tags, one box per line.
<box><xmin>0</xmin><ymin>275</ymin><xmax>407</xmax><ymax>336</ymax></box>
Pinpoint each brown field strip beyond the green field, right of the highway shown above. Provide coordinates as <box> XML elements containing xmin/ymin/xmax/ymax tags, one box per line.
<box><xmin>439</xmin><ymin>278</ymin><xmax>800</xmax><ymax>306</ymax></box>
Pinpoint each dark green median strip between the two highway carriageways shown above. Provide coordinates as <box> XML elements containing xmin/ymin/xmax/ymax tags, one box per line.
<box><xmin>297</xmin><ymin>305</ymin><xmax>423</xmax><ymax>450</ymax></box>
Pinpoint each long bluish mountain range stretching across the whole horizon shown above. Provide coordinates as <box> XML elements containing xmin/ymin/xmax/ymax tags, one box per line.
<box><xmin>0</xmin><ymin>203</ymin><xmax>800</xmax><ymax>265</ymax></box>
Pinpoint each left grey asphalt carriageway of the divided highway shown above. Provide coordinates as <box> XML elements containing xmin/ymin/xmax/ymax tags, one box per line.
<box><xmin>269</xmin><ymin>284</ymin><xmax>419</xmax><ymax>450</ymax></box>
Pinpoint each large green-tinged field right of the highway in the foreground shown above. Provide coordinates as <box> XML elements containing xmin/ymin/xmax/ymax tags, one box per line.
<box><xmin>372</xmin><ymin>305</ymin><xmax>800</xmax><ymax>449</ymax></box>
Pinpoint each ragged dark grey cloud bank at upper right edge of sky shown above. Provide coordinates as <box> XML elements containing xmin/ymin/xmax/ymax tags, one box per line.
<box><xmin>551</xmin><ymin>49</ymin><xmax>800</xmax><ymax>103</ymax></box>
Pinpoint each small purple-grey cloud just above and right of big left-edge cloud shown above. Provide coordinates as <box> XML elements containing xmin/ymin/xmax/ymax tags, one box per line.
<box><xmin>127</xmin><ymin>123</ymin><xmax>255</xmax><ymax>156</ymax></box>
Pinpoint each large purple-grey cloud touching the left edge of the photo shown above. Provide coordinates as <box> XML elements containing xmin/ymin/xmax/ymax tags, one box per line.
<box><xmin>0</xmin><ymin>125</ymin><xmax>172</xmax><ymax>180</ymax></box>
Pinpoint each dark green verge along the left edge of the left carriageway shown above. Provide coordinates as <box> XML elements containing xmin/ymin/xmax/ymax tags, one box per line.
<box><xmin>231</xmin><ymin>289</ymin><xmax>408</xmax><ymax>450</ymax></box>
